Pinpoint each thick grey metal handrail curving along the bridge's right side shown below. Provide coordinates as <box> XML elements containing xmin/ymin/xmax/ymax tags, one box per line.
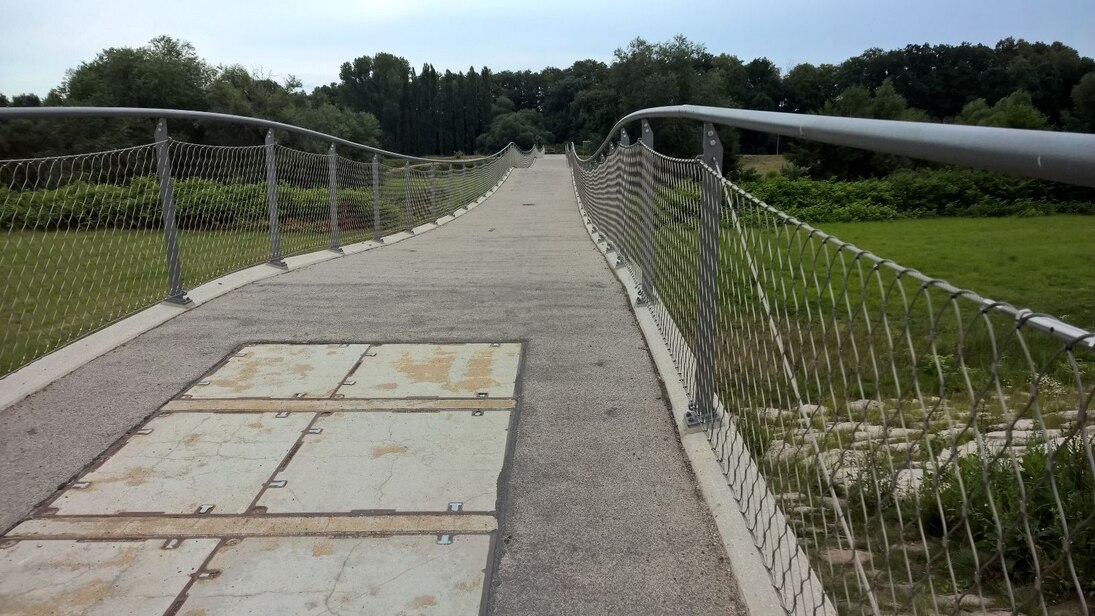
<box><xmin>579</xmin><ymin>105</ymin><xmax>1095</xmax><ymax>187</ymax></box>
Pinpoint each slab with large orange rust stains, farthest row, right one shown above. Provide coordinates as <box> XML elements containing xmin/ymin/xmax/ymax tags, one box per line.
<box><xmin>338</xmin><ymin>344</ymin><xmax>521</xmax><ymax>398</ymax></box>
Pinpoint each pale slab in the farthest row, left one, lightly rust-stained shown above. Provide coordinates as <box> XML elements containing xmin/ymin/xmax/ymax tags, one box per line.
<box><xmin>183</xmin><ymin>345</ymin><xmax>369</xmax><ymax>398</ymax></box>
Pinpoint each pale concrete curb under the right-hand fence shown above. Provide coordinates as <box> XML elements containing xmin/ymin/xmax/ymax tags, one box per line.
<box><xmin>572</xmin><ymin>176</ymin><xmax>786</xmax><ymax>616</ymax></box>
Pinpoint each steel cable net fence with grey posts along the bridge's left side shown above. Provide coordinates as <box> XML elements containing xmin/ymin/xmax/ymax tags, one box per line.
<box><xmin>0</xmin><ymin>117</ymin><xmax>541</xmax><ymax>376</ymax></box>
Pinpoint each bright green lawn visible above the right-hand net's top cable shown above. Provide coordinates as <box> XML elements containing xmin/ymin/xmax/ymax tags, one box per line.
<box><xmin>818</xmin><ymin>216</ymin><xmax>1095</xmax><ymax>329</ymax></box>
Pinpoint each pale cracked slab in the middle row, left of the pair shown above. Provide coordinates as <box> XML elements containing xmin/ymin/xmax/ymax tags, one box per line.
<box><xmin>53</xmin><ymin>412</ymin><xmax>313</xmax><ymax>515</ymax></box>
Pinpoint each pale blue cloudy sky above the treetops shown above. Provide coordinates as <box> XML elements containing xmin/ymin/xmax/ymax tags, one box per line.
<box><xmin>0</xmin><ymin>0</ymin><xmax>1095</xmax><ymax>95</ymax></box>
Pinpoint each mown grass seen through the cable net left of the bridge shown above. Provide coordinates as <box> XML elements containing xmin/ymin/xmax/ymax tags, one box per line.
<box><xmin>0</xmin><ymin>225</ymin><xmax>330</xmax><ymax>374</ymax></box>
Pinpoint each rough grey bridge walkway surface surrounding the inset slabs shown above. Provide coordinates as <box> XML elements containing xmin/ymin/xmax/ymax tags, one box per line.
<box><xmin>0</xmin><ymin>156</ymin><xmax>745</xmax><ymax>615</ymax></box>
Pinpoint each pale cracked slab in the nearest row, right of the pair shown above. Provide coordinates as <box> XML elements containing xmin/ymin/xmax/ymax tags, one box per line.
<box><xmin>178</xmin><ymin>535</ymin><xmax>489</xmax><ymax>616</ymax></box>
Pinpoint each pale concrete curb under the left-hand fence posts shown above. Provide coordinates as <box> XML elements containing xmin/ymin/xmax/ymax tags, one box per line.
<box><xmin>0</xmin><ymin>168</ymin><xmax>514</xmax><ymax>412</ymax></box>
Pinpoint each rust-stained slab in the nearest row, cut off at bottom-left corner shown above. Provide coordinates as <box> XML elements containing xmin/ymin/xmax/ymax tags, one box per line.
<box><xmin>0</xmin><ymin>539</ymin><xmax>217</xmax><ymax>616</ymax></box>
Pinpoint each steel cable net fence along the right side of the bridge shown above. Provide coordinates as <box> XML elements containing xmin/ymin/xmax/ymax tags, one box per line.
<box><xmin>568</xmin><ymin>143</ymin><xmax>1095</xmax><ymax>614</ymax></box>
